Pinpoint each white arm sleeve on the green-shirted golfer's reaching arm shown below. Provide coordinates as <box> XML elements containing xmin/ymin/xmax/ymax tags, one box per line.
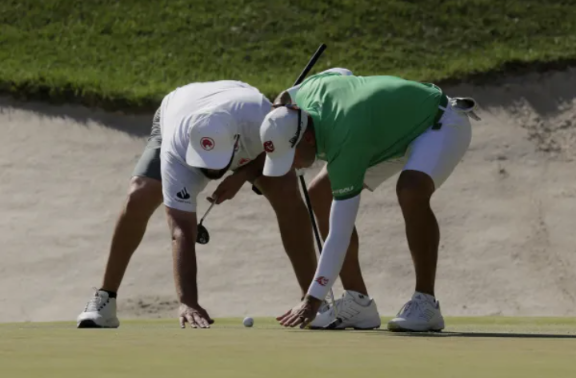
<box><xmin>308</xmin><ymin>194</ymin><xmax>360</xmax><ymax>300</ymax></box>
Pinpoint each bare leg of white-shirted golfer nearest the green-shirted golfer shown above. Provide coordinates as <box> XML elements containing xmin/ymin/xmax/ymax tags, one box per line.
<box><xmin>255</xmin><ymin>171</ymin><xmax>318</xmax><ymax>297</ymax></box>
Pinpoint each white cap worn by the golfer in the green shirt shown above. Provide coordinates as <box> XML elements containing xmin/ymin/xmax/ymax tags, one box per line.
<box><xmin>260</xmin><ymin>106</ymin><xmax>308</xmax><ymax>176</ymax></box>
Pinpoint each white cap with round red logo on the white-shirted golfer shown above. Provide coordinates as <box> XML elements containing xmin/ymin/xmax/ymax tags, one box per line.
<box><xmin>186</xmin><ymin>111</ymin><xmax>238</xmax><ymax>169</ymax></box>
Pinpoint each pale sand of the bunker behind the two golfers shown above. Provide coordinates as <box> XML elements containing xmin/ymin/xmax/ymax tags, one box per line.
<box><xmin>0</xmin><ymin>69</ymin><xmax>576</xmax><ymax>325</ymax></box>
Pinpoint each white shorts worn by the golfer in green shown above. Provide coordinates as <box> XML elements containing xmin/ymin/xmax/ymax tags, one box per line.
<box><xmin>364</xmin><ymin>98</ymin><xmax>472</xmax><ymax>191</ymax></box>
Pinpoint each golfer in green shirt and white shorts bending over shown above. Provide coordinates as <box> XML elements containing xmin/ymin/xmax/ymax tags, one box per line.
<box><xmin>260</xmin><ymin>69</ymin><xmax>477</xmax><ymax>331</ymax></box>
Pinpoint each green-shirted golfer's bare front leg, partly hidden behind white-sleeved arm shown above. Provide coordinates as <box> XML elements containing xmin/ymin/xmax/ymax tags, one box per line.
<box><xmin>308</xmin><ymin>167</ymin><xmax>368</xmax><ymax>295</ymax></box>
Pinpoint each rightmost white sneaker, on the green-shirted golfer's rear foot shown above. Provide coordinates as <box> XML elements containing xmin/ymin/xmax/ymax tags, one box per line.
<box><xmin>388</xmin><ymin>292</ymin><xmax>444</xmax><ymax>332</ymax></box>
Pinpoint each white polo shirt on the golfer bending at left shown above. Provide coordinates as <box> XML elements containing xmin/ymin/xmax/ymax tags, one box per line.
<box><xmin>160</xmin><ymin>80</ymin><xmax>272</xmax><ymax>212</ymax></box>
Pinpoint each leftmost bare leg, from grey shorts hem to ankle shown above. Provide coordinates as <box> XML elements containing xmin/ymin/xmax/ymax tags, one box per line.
<box><xmin>101</xmin><ymin>177</ymin><xmax>162</xmax><ymax>293</ymax></box>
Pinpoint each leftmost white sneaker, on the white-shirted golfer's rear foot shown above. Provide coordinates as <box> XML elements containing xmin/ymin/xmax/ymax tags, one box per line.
<box><xmin>76</xmin><ymin>290</ymin><xmax>120</xmax><ymax>328</ymax></box>
